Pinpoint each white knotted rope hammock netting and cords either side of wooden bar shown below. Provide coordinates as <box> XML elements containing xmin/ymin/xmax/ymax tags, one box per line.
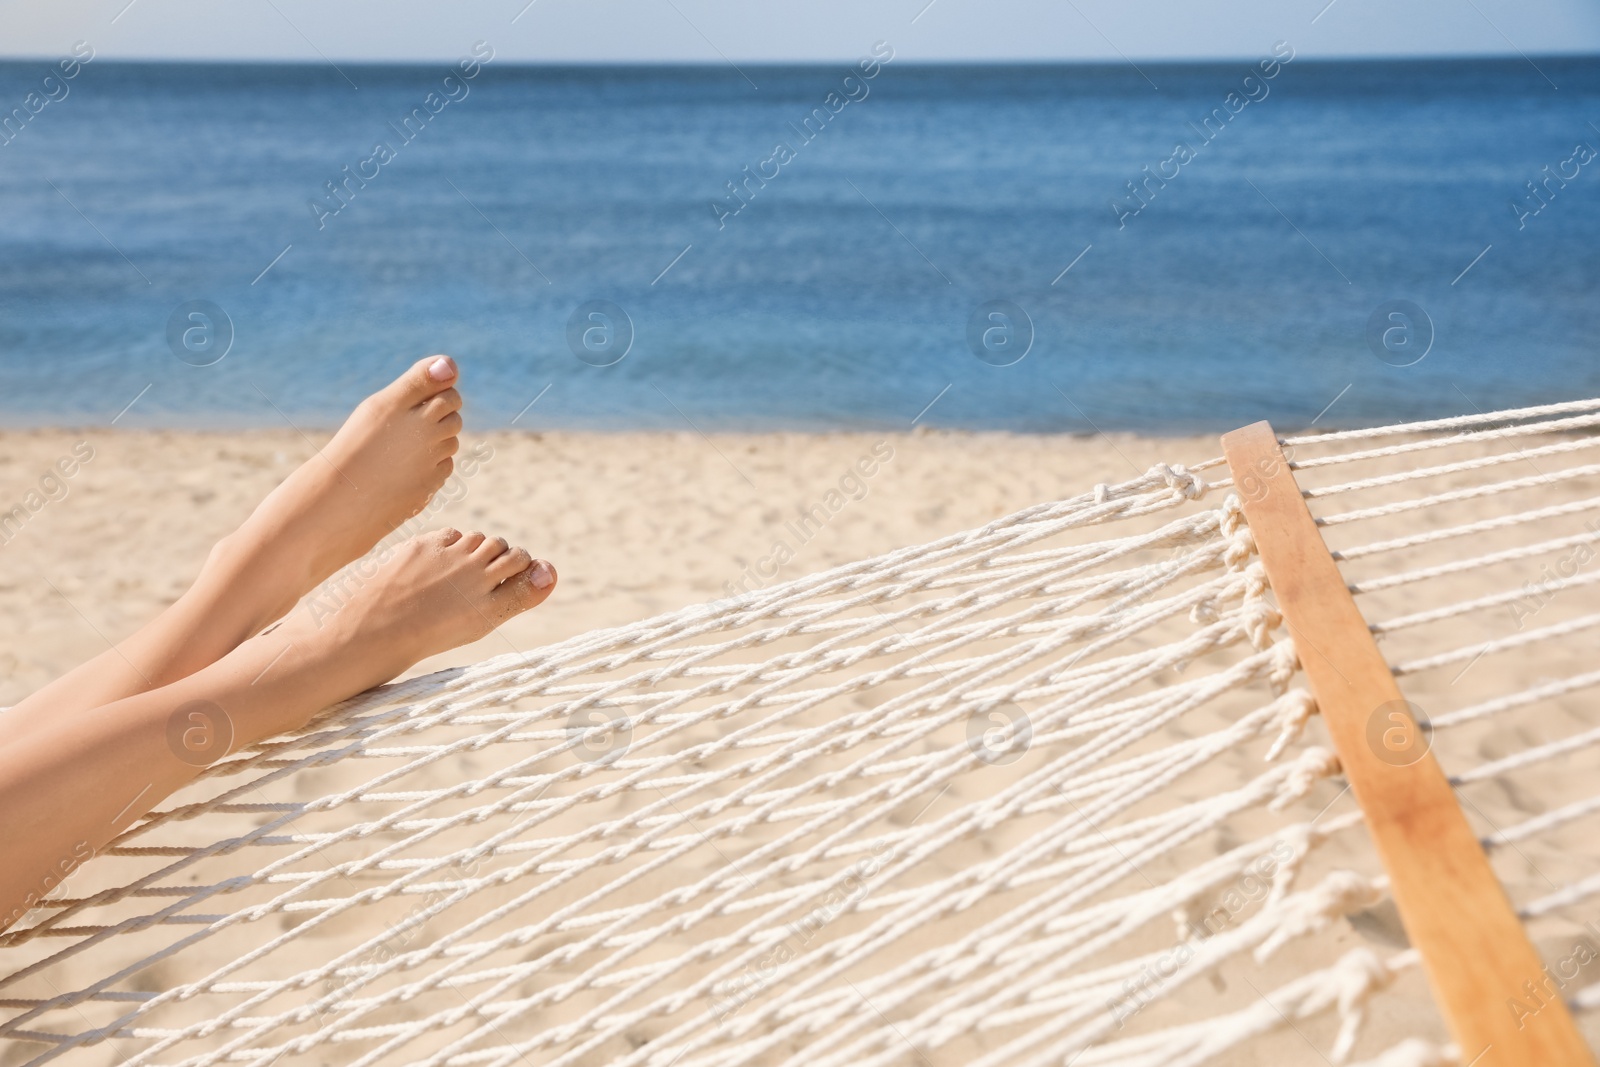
<box><xmin>0</xmin><ymin>400</ymin><xmax>1600</xmax><ymax>1067</ymax></box>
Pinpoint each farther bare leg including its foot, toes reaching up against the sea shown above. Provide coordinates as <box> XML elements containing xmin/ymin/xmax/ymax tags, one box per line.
<box><xmin>0</xmin><ymin>355</ymin><xmax>461</xmax><ymax>729</ymax></box>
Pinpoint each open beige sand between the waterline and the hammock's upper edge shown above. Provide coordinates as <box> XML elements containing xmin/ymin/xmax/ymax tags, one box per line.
<box><xmin>0</xmin><ymin>429</ymin><xmax>1218</xmax><ymax>704</ymax></box>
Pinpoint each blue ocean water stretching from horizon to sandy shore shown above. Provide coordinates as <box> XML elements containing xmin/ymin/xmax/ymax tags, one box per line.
<box><xmin>0</xmin><ymin>50</ymin><xmax>1600</xmax><ymax>434</ymax></box>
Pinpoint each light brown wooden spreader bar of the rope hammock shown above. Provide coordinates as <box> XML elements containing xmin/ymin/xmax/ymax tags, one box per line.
<box><xmin>1222</xmin><ymin>422</ymin><xmax>1595</xmax><ymax>1067</ymax></box>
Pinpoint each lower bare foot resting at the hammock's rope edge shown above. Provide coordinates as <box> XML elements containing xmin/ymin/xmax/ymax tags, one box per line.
<box><xmin>267</xmin><ymin>530</ymin><xmax>555</xmax><ymax>697</ymax></box>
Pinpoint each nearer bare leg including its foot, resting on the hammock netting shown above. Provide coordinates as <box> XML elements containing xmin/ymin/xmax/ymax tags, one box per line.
<box><xmin>0</xmin><ymin>530</ymin><xmax>555</xmax><ymax>929</ymax></box>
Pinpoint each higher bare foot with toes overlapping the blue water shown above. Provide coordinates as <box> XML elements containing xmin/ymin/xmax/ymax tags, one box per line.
<box><xmin>202</xmin><ymin>355</ymin><xmax>461</xmax><ymax>639</ymax></box>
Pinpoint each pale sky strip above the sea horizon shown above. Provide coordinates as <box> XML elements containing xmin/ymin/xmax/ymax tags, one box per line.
<box><xmin>0</xmin><ymin>0</ymin><xmax>1600</xmax><ymax>62</ymax></box>
